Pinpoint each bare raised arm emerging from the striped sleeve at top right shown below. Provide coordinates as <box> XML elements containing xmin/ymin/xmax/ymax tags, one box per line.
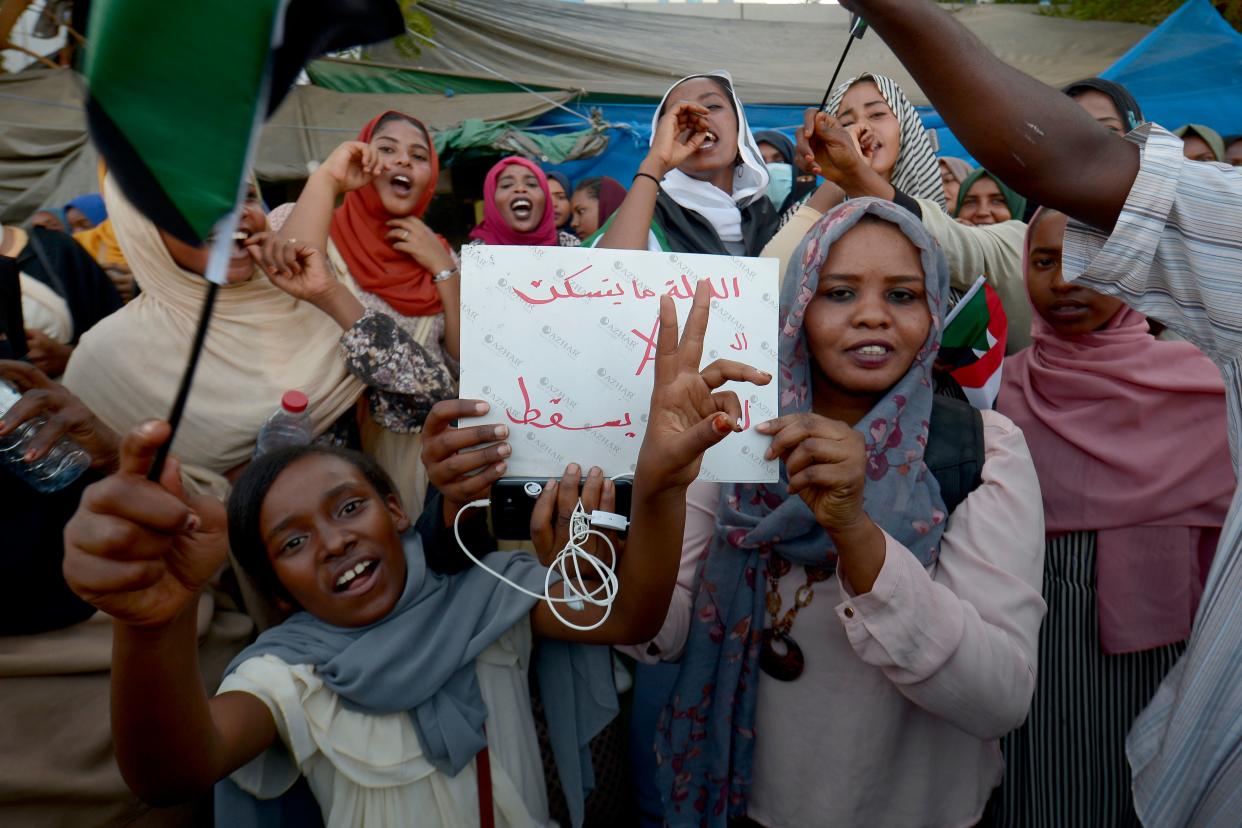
<box><xmin>842</xmin><ymin>0</ymin><xmax>1139</xmax><ymax>230</ymax></box>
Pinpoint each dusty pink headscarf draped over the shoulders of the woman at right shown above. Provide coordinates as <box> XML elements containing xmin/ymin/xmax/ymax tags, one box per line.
<box><xmin>997</xmin><ymin>211</ymin><xmax>1235</xmax><ymax>653</ymax></box>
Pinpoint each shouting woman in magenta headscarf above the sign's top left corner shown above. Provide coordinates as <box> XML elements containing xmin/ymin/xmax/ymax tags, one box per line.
<box><xmin>469</xmin><ymin>156</ymin><xmax>579</xmax><ymax>247</ymax></box>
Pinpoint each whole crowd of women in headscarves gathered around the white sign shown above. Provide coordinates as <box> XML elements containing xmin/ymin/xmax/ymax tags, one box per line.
<box><xmin>0</xmin><ymin>0</ymin><xmax>1242</xmax><ymax>828</ymax></box>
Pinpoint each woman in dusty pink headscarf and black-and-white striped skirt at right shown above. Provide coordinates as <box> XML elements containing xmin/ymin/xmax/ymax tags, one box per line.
<box><xmin>995</xmin><ymin>210</ymin><xmax>1235</xmax><ymax>828</ymax></box>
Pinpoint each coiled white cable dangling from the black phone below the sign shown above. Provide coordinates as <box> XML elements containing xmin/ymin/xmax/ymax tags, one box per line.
<box><xmin>453</xmin><ymin>496</ymin><xmax>621</xmax><ymax>632</ymax></box>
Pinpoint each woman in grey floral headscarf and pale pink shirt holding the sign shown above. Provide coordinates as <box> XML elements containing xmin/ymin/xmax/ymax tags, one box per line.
<box><xmin>648</xmin><ymin>199</ymin><xmax>1045</xmax><ymax>828</ymax></box>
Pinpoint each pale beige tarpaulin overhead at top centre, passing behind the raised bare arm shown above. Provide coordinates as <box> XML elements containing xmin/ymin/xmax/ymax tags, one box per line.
<box><xmin>365</xmin><ymin>0</ymin><xmax>1150</xmax><ymax>106</ymax></box>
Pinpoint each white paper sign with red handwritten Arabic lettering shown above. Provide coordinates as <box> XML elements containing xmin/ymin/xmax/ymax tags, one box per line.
<box><xmin>460</xmin><ymin>245</ymin><xmax>779</xmax><ymax>483</ymax></box>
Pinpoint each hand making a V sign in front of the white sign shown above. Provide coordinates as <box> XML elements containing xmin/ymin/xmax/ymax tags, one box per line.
<box><xmin>635</xmin><ymin>281</ymin><xmax>771</xmax><ymax>490</ymax></box>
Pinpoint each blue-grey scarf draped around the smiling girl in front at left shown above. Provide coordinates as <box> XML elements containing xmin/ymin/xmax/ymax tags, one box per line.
<box><xmin>216</xmin><ymin>530</ymin><xmax>619</xmax><ymax>828</ymax></box>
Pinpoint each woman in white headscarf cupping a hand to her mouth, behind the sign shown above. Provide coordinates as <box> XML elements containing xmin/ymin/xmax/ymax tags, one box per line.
<box><xmin>597</xmin><ymin>70</ymin><xmax>779</xmax><ymax>256</ymax></box>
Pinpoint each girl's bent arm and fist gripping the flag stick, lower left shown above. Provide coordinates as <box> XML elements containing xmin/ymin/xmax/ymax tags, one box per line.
<box><xmin>65</xmin><ymin>422</ymin><xmax>277</xmax><ymax>804</ymax></box>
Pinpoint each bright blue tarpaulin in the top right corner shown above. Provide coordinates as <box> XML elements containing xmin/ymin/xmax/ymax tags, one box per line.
<box><xmin>1103</xmin><ymin>0</ymin><xmax>1242</xmax><ymax>133</ymax></box>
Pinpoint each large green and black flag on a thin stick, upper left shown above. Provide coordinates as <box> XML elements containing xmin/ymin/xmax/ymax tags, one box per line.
<box><xmin>84</xmin><ymin>0</ymin><xmax>405</xmax><ymax>479</ymax></box>
